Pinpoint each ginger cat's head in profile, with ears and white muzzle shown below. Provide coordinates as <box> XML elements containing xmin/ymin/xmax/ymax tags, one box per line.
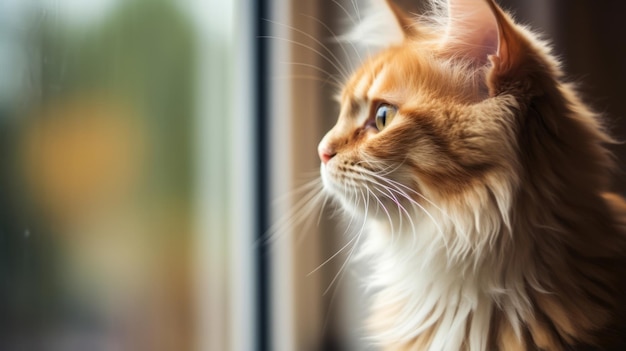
<box><xmin>318</xmin><ymin>0</ymin><xmax>603</xmax><ymax>230</ymax></box>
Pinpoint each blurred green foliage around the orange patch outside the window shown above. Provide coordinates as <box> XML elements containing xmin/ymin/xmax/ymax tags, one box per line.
<box><xmin>0</xmin><ymin>0</ymin><xmax>196</xmax><ymax>350</ymax></box>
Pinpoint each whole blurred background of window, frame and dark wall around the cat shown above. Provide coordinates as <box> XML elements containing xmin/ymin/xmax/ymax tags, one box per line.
<box><xmin>0</xmin><ymin>0</ymin><xmax>626</xmax><ymax>351</ymax></box>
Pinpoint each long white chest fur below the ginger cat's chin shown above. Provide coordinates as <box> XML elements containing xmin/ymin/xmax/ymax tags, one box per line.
<box><xmin>363</xmin><ymin>195</ymin><xmax>529</xmax><ymax>351</ymax></box>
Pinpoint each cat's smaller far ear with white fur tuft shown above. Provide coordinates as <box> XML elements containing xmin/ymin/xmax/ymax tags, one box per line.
<box><xmin>343</xmin><ymin>0</ymin><xmax>417</xmax><ymax>48</ymax></box>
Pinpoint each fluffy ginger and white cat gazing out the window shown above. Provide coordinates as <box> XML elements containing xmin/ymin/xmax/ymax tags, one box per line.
<box><xmin>318</xmin><ymin>0</ymin><xmax>626</xmax><ymax>351</ymax></box>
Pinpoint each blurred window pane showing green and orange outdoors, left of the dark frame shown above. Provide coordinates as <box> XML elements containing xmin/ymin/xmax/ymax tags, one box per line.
<box><xmin>0</xmin><ymin>0</ymin><xmax>253</xmax><ymax>351</ymax></box>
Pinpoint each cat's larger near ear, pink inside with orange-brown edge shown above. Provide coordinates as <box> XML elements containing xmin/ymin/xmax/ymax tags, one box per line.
<box><xmin>442</xmin><ymin>0</ymin><xmax>529</xmax><ymax>72</ymax></box>
